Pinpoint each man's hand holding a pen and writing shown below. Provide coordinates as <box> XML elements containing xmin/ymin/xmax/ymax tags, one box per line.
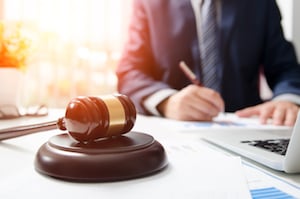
<box><xmin>158</xmin><ymin>85</ymin><xmax>224</xmax><ymax>121</ymax></box>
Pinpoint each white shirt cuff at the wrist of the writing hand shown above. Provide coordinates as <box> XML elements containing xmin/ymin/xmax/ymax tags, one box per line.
<box><xmin>143</xmin><ymin>89</ymin><xmax>178</xmax><ymax>116</ymax></box>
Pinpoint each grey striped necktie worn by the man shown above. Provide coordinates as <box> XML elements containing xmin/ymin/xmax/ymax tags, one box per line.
<box><xmin>200</xmin><ymin>0</ymin><xmax>220</xmax><ymax>90</ymax></box>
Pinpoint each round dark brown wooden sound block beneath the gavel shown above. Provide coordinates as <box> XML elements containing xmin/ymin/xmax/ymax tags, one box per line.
<box><xmin>35</xmin><ymin>132</ymin><xmax>167</xmax><ymax>182</ymax></box>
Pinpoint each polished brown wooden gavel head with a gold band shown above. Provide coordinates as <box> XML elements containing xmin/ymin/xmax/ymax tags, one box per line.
<box><xmin>57</xmin><ymin>94</ymin><xmax>136</xmax><ymax>142</ymax></box>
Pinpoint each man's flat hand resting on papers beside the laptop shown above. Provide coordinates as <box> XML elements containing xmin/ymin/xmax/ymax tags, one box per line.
<box><xmin>236</xmin><ymin>101</ymin><xmax>299</xmax><ymax>126</ymax></box>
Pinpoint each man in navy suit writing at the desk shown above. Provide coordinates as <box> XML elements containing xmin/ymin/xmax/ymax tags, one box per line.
<box><xmin>117</xmin><ymin>0</ymin><xmax>300</xmax><ymax>126</ymax></box>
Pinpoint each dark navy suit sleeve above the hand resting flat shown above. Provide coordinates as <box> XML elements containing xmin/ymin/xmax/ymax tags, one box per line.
<box><xmin>263</xmin><ymin>0</ymin><xmax>300</xmax><ymax>97</ymax></box>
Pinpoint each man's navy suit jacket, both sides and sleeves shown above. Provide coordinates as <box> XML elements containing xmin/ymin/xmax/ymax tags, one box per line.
<box><xmin>116</xmin><ymin>0</ymin><xmax>300</xmax><ymax>114</ymax></box>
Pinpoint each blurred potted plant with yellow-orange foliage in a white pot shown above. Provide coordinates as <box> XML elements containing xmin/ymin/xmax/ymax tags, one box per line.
<box><xmin>0</xmin><ymin>21</ymin><xmax>32</xmax><ymax>118</ymax></box>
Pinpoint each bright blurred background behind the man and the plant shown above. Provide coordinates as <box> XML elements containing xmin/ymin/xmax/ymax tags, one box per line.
<box><xmin>0</xmin><ymin>0</ymin><xmax>300</xmax><ymax>107</ymax></box>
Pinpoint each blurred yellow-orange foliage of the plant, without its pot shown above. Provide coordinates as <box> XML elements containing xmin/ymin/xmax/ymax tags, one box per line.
<box><xmin>0</xmin><ymin>22</ymin><xmax>31</xmax><ymax>69</ymax></box>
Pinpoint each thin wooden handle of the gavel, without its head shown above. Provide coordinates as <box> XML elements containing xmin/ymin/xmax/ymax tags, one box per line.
<box><xmin>0</xmin><ymin>121</ymin><xmax>57</xmax><ymax>141</ymax></box>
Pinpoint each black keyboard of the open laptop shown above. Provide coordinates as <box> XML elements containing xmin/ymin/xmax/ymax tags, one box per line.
<box><xmin>242</xmin><ymin>139</ymin><xmax>290</xmax><ymax>155</ymax></box>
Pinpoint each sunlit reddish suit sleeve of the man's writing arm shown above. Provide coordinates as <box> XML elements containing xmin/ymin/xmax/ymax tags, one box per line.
<box><xmin>116</xmin><ymin>0</ymin><xmax>169</xmax><ymax>114</ymax></box>
